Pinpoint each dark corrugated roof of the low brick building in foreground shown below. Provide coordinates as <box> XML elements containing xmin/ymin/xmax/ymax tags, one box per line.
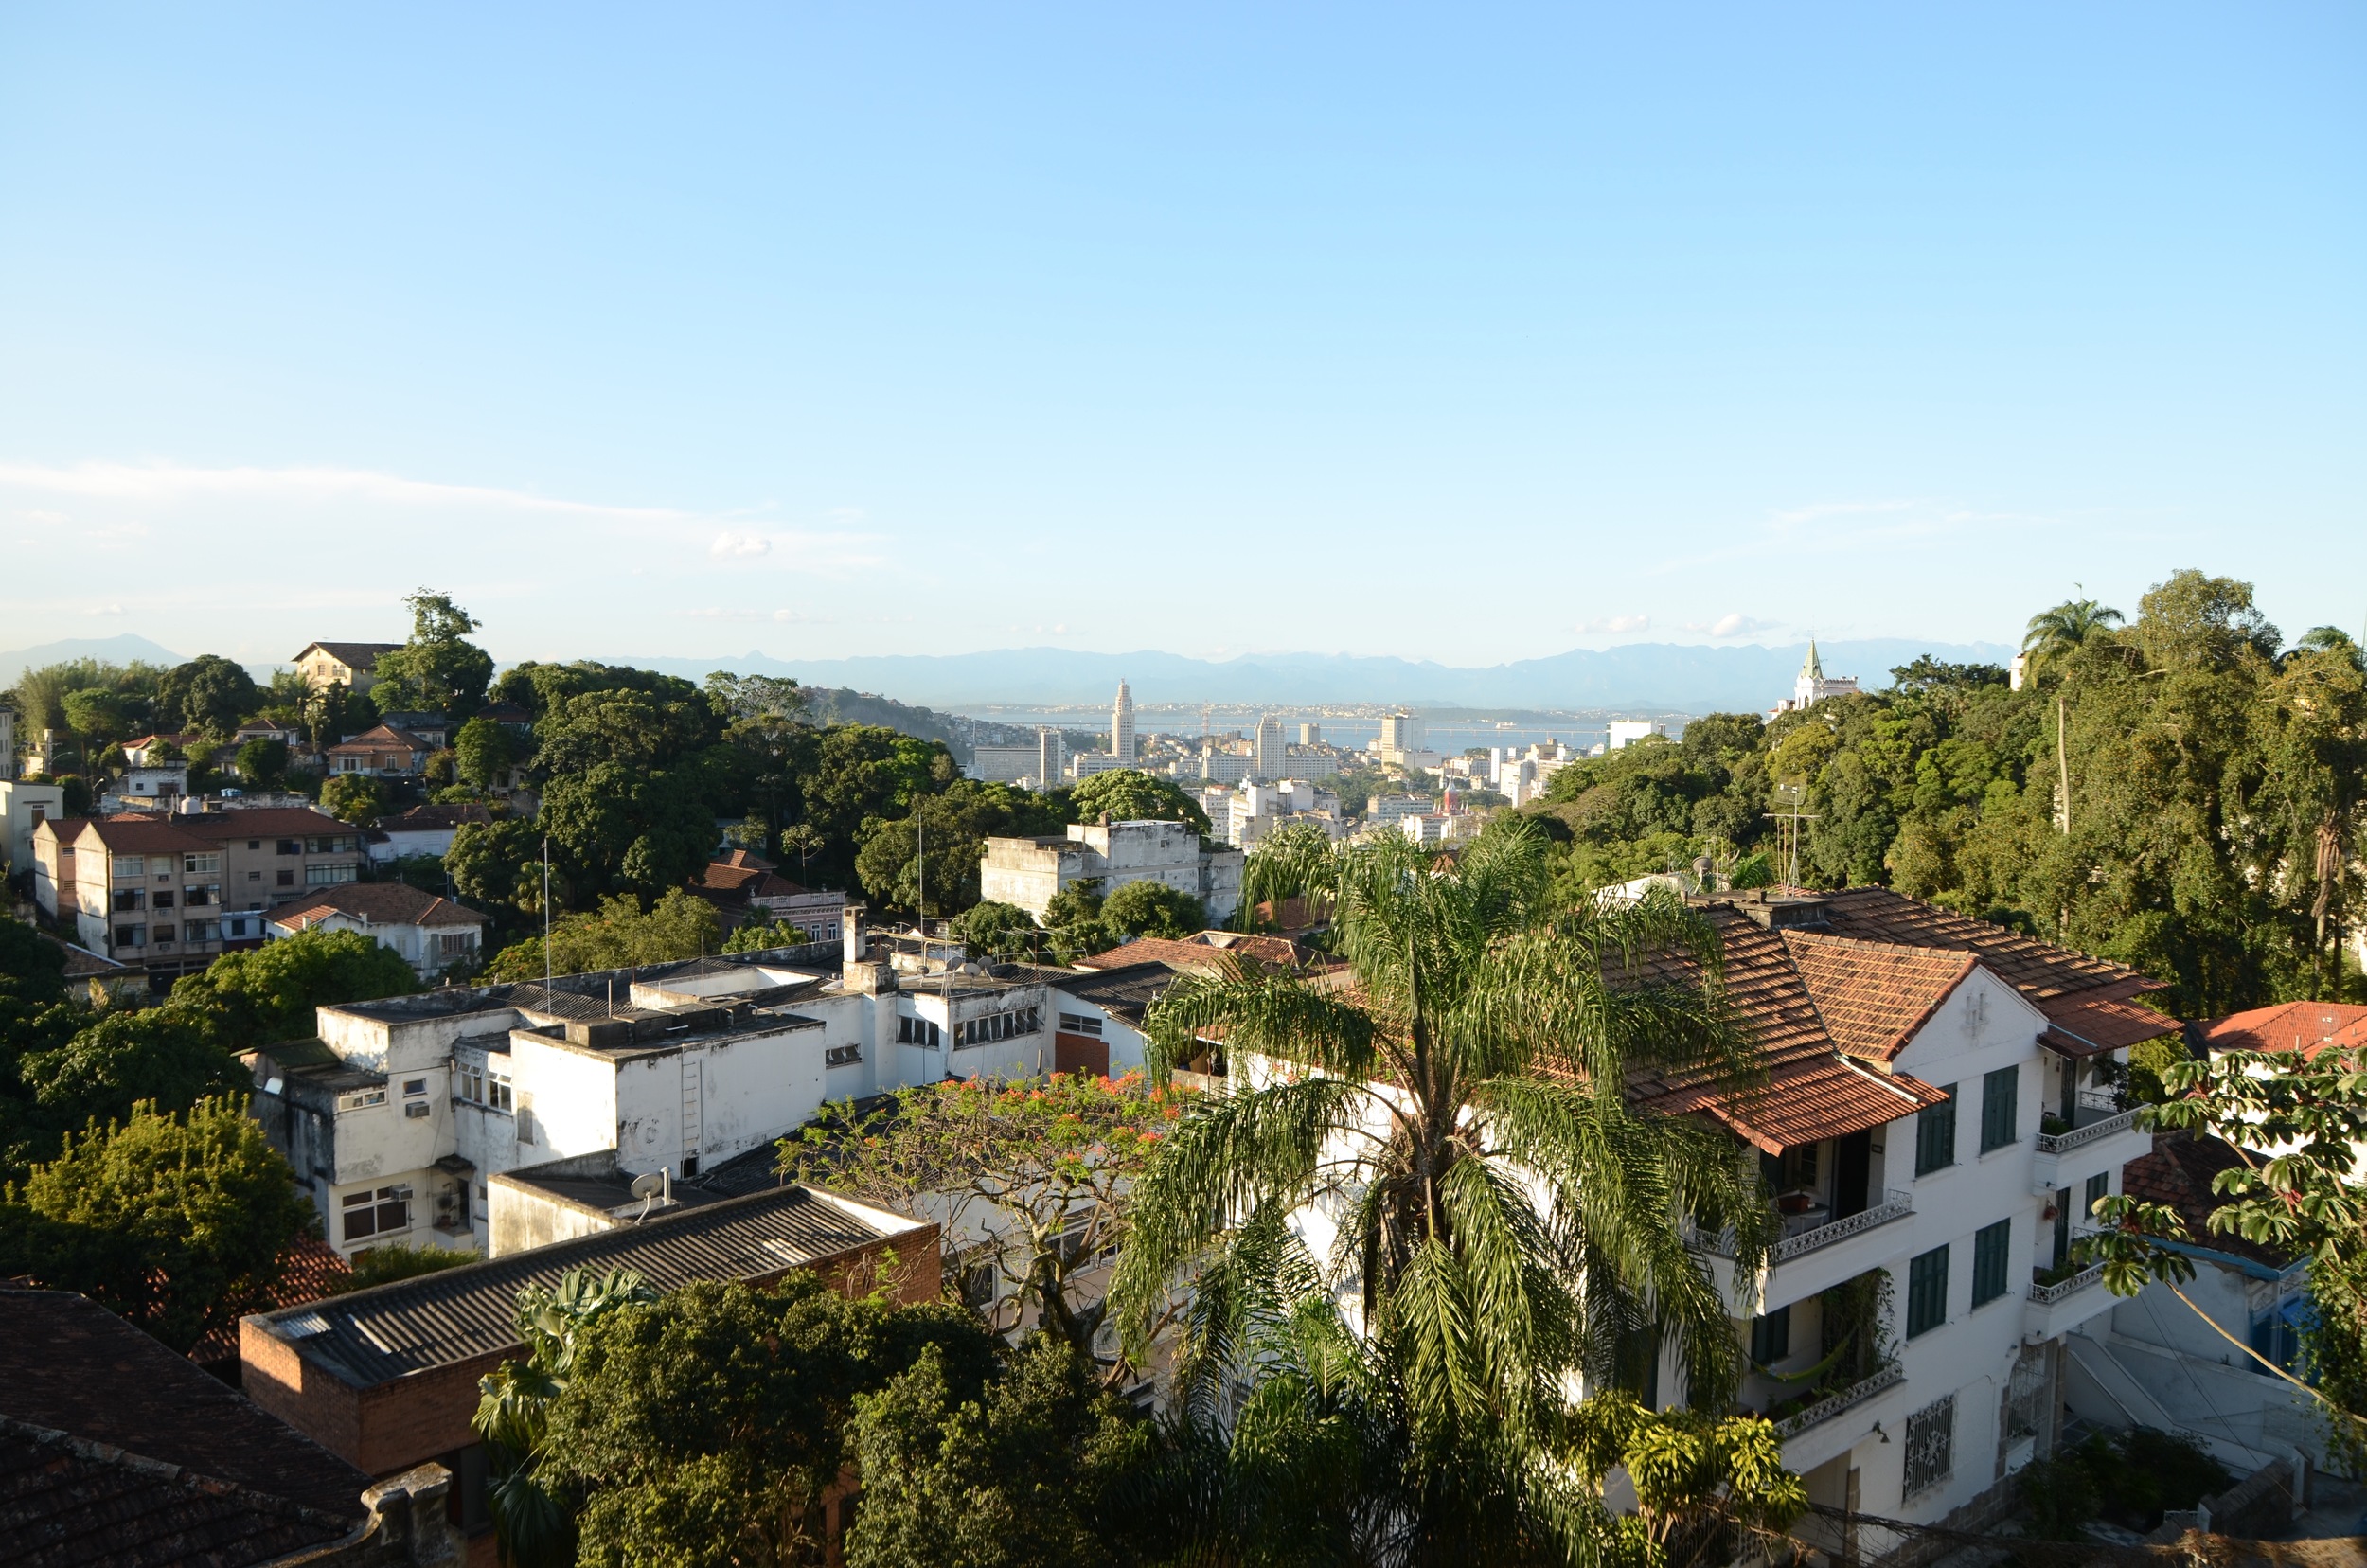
<box><xmin>260</xmin><ymin>1186</ymin><xmax>885</xmax><ymax>1388</ymax></box>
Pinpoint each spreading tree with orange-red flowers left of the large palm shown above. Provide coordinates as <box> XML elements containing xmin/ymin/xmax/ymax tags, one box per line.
<box><xmin>779</xmin><ymin>1073</ymin><xmax>1188</xmax><ymax>1388</ymax></box>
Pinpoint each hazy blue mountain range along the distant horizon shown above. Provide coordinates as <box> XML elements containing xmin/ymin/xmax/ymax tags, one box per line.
<box><xmin>630</xmin><ymin>637</ymin><xmax>2015</xmax><ymax>713</ymax></box>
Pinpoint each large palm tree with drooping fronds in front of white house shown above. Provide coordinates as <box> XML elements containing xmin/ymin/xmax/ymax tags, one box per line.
<box><xmin>1112</xmin><ymin>822</ymin><xmax>1769</xmax><ymax>1559</ymax></box>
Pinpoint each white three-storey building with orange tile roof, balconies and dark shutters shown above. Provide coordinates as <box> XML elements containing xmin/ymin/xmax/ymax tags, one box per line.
<box><xmin>1647</xmin><ymin>888</ymin><xmax>2180</xmax><ymax>1546</ymax></box>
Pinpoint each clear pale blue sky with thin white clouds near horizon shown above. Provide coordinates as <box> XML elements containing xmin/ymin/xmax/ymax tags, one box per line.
<box><xmin>0</xmin><ymin>5</ymin><xmax>2367</xmax><ymax>663</ymax></box>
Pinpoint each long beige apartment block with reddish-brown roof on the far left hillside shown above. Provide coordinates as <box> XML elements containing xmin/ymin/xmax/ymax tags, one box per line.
<box><xmin>64</xmin><ymin>808</ymin><xmax>363</xmax><ymax>976</ymax></box>
